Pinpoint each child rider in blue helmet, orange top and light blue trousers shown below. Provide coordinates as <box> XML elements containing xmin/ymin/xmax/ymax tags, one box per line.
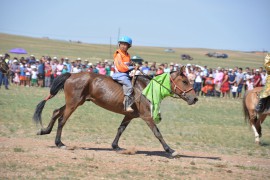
<box><xmin>112</xmin><ymin>36</ymin><xmax>134</xmax><ymax>112</ymax></box>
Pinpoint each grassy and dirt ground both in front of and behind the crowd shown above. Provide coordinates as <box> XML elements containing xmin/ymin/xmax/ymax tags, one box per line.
<box><xmin>0</xmin><ymin>34</ymin><xmax>270</xmax><ymax>179</ymax></box>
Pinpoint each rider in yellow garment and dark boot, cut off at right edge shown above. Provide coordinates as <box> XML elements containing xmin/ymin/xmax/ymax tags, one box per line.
<box><xmin>255</xmin><ymin>54</ymin><xmax>270</xmax><ymax>112</ymax></box>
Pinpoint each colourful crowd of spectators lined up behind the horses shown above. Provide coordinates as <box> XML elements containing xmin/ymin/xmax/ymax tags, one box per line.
<box><xmin>0</xmin><ymin>55</ymin><xmax>267</xmax><ymax>98</ymax></box>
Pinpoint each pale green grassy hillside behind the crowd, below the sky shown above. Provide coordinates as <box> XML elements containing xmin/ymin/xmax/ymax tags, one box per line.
<box><xmin>0</xmin><ymin>33</ymin><xmax>266</xmax><ymax>68</ymax></box>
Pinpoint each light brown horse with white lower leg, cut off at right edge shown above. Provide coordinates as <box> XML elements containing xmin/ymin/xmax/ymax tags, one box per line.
<box><xmin>243</xmin><ymin>87</ymin><xmax>270</xmax><ymax>144</ymax></box>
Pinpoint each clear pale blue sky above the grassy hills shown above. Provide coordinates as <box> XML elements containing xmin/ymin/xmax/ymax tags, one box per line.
<box><xmin>0</xmin><ymin>0</ymin><xmax>270</xmax><ymax>51</ymax></box>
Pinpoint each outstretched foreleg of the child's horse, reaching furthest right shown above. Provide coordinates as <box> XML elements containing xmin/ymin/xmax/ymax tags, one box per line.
<box><xmin>144</xmin><ymin>118</ymin><xmax>176</xmax><ymax>156</ymax></box>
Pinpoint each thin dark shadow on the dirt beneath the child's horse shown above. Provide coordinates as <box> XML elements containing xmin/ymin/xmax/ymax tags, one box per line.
<box><xmin>57</xmin><ymin>147</ymin><xmax>221</xmax><ymax>161</ymax></box>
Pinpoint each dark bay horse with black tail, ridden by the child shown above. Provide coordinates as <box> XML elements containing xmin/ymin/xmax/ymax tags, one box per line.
<box><xmin>33</xmin><ymin>67</ymin><xmax>198</xmax><ymax>156</ymax></box>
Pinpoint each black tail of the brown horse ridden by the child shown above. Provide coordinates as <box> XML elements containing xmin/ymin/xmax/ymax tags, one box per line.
<box><xmin>33</xmin><ymin>73</ymin><xmax>71</xmax><ymax>126</ymax></box>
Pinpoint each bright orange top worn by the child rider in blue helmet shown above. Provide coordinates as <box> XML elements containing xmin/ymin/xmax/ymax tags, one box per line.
<box><xmin>113</xmin><ymin>49</ymin><xmax>131</xmax><ymax>72</ymax></box>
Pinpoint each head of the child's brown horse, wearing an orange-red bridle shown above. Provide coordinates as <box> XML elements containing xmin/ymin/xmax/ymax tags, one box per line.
<box><xmin>170</xmin><ymin>66</ymin><xmax>198</xmax><ymax>105</ymax></box>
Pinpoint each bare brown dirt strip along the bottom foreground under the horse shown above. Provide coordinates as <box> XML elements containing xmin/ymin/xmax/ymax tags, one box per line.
<box><xmin>0</xmin><ymin>138</ymin><xmax>270</xmax><ymax>179</ymax></box>
